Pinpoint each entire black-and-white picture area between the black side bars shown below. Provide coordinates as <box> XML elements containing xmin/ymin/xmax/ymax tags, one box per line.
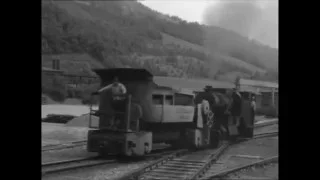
<box><xmin>41</xmin><ymin>0</ymin><xmax>282</xmax><ymax>180</ymax></box>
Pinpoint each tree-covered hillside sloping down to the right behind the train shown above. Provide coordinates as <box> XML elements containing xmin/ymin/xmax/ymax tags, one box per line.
<box><xmin>42</xmin><ymin>0</ymin><xmax>278</xmax><ymax>80</ymax></box>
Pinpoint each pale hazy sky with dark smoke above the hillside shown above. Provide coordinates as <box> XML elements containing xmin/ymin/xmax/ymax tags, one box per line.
<box><xmin>141</xmin><ymin>0</ymin><xmax>278</xmax><ymax>48</ymax></box>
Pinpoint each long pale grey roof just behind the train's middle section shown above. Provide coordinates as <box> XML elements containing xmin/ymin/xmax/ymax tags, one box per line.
<box><xmin>153</xmin><ymin>76</ymin><xmax>234</xmax><ymax>91</ymax></box>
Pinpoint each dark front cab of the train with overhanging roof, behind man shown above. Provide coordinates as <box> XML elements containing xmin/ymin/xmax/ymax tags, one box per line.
<box><xmin>87</xmin><ymin>69</ymin><xmax>152</xmax><ymax>156</ymax></box>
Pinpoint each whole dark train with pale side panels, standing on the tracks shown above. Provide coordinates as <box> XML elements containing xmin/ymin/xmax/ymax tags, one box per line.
<box><xmin>87</xmin><ymin>68</ymin><xmax>254</xmax><ymax>156</ymax></box>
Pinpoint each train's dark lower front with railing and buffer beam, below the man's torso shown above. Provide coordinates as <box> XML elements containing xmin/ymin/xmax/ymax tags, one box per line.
<box><xmin>87</xmin><ymin>95</ymin><xmax>152</xmax><ymax>156</ymax></box>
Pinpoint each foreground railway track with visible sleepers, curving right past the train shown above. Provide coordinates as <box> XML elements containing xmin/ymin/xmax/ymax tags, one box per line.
<box><xmin>118</xmin><ymin>132</ymin><xmax>278</xmax><ymax>180</ymax></box>
